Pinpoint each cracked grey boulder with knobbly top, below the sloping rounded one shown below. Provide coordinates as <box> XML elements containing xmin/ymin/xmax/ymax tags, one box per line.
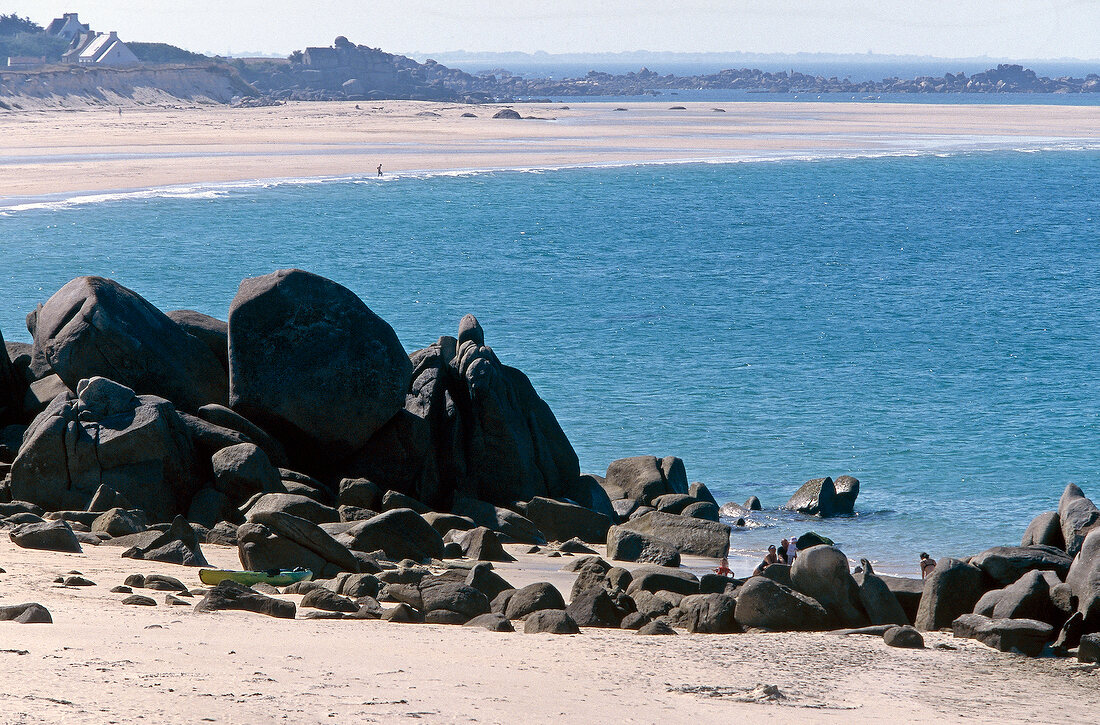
<box><xmin>11</xmin><ymin>377</ymin><xmax>204</xmax><ymax>521</ymax></box>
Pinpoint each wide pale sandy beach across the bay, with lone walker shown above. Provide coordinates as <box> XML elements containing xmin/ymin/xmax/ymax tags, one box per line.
<box><xmin>0</xmin><ymin>99</ymin><xmax>1100</xmax><ymax>201</ymax></box>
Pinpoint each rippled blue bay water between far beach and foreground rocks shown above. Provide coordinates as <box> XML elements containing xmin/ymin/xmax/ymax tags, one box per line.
<box><xmin>0</xmin><ymin>147</ymin><xmax>1100</xmax><ymax>573</ymax></box>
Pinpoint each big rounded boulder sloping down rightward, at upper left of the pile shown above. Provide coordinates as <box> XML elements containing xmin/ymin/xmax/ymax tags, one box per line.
<box><xmin>28</xmin><ymin>277</ymin><xmax>228</xmax><ymax>411</ymax></box>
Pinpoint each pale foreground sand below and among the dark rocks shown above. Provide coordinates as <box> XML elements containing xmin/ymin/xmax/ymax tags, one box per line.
<box><xmin>0</xmin><ymin>536</ymin><xmax>1100</xmax><ymax>723</ymax></box>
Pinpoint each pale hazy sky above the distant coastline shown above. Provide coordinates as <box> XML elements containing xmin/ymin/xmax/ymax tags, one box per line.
<box><xmin>8</xmin><ymin>0</ymin><xmax>1100</xmax><ymax>59</ymax></box>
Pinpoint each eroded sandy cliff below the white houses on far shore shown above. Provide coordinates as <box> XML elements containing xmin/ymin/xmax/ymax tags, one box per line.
<box><xmin>0</xmin><ymin>63</ymin><xmax>256</xmax><ymax>111</ymax></box>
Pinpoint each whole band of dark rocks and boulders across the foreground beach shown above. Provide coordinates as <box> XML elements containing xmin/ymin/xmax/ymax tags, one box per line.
<box><xmin>0</xmin><ymin>270</ymin><xmax>1100</xmax><ymax>662</ymax></box>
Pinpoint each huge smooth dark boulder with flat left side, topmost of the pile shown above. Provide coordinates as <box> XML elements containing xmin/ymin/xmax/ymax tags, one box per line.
<box><xmin>229</xmin><ymin>270</ymin><xmax>413</xmax><ymax>463</ymax></box>
